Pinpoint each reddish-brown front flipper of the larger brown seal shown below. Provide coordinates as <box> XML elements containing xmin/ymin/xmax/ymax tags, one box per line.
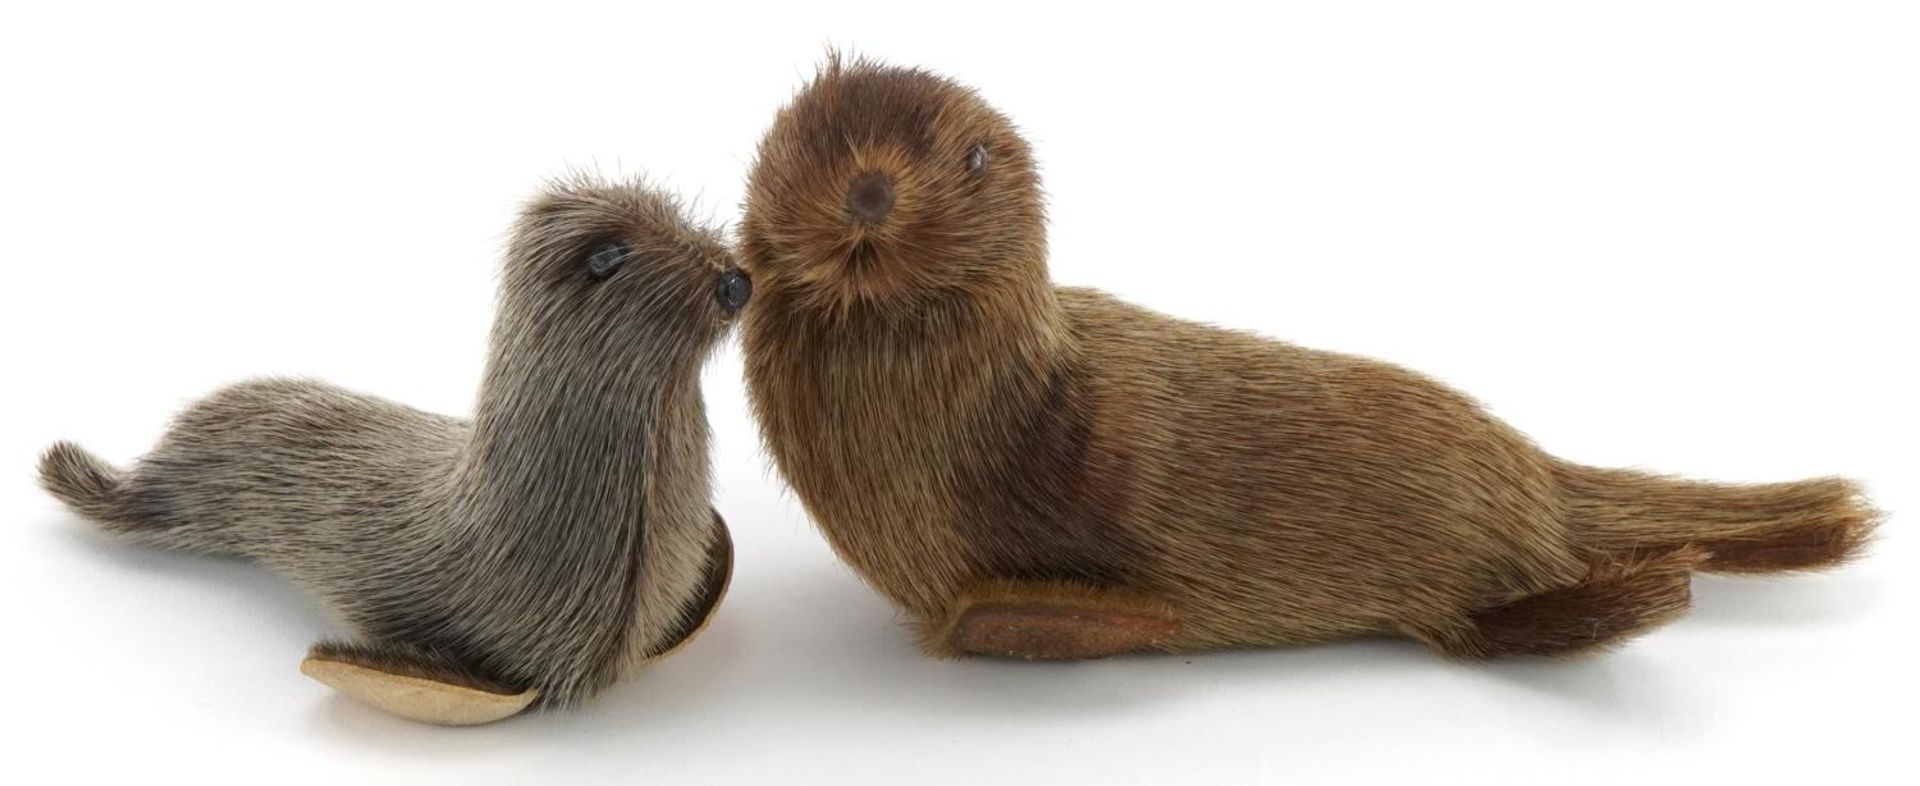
<box><xmin>924</xmin><ymin>580</ymin><xmax>1181</xmax><ymax>661</ymax></box>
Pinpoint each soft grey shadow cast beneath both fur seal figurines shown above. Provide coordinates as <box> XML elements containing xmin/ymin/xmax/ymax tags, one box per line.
<box><xmin>65</xmin><ymin>515</ymin><xmax>1712</xmax><ymax>745</ymax></box>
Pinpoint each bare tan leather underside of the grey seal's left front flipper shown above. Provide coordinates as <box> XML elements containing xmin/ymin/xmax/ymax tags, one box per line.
<box><xmin>300</xmin><ymin>657</ymin><xmax>540</xmax><ymax>726</ymax></box>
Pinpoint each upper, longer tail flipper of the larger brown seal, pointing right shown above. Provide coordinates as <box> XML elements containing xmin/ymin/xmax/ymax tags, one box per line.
<box><xmin>1559</xmin><ymin>465</ymin><xmax>1882</xmax><ymax>573</ymax></box>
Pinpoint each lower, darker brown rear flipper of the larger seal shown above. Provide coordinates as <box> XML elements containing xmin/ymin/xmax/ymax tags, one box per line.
<box><xmin>1407</xmin><ymin>548</ymin><xmax>1707</xmax><ymax>659</ymax></box>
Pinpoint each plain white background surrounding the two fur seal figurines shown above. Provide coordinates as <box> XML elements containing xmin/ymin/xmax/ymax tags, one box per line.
<box><xmin>0</xmin><ymin>0</ymin><xmax>1920</xmax><ymax>784</ymax></box>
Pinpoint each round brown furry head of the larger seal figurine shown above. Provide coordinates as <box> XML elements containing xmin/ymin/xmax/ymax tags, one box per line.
<box><xmin>741</xmin><ymin>56</ymin><xmax>1046</xmax><ymax>306</ymax></box>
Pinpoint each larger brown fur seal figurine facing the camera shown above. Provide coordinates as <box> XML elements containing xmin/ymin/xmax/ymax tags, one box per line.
<box><xmin>739</xmin><ymin>58</ymin><xmax>1876</xmax><ymax>659</ymax></box>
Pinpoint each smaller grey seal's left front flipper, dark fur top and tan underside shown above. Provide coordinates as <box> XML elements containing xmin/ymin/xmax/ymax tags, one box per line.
<box><xmin>300</xmin><ymin>642</ymin><xmax>540</xmax><ymax>726</ymax></box>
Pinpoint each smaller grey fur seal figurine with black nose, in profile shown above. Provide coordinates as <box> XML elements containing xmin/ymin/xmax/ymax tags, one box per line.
<box><xmin>40</xmin><ymin>179</ymin><xmax>751</xmax><ymax>725</ymax></box>
